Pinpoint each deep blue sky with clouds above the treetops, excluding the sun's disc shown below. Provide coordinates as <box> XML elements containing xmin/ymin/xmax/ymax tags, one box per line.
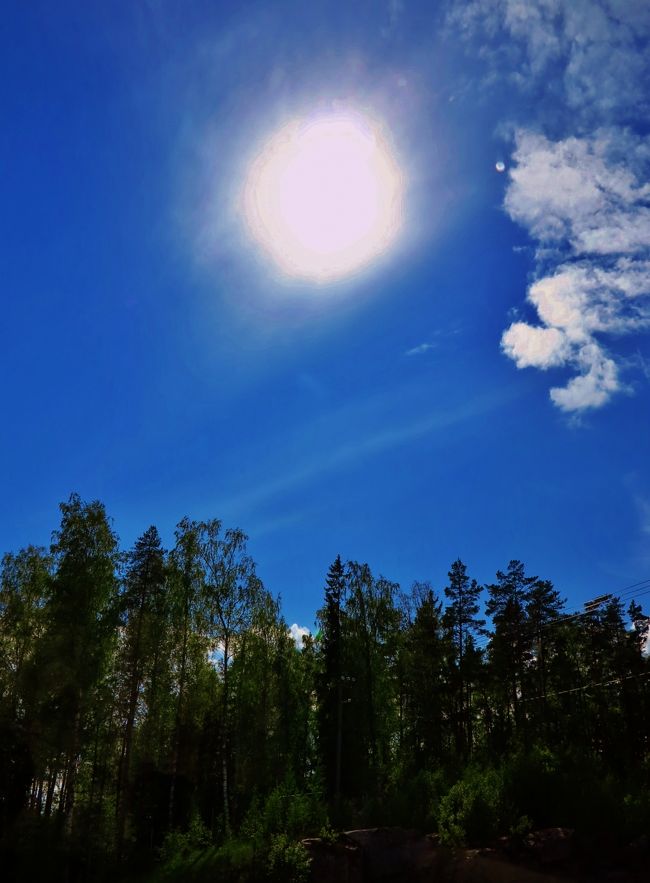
<box><xmin>0</xmin><ymin>0</ymin><xmax>650</xmax><ymax>625</ymax></box>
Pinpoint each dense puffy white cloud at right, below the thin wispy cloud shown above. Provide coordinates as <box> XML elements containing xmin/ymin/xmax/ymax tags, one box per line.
<box><xmin>501</xmin><ymin>131</ymin><xmax>650</xmax><ymax>412</ymax></box>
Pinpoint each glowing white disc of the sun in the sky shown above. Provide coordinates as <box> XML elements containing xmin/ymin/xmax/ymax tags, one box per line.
<box><xmin>244</xmin><ymin>114</ymin><xmax>402</xmax><ymax>282</ymax></box>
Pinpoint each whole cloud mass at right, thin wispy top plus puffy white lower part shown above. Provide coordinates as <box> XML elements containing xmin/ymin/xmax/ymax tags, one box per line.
<box><xmin>448</xmin><ymin>0</ymin><xmax>650</xmax><ymax>412</ymax></box>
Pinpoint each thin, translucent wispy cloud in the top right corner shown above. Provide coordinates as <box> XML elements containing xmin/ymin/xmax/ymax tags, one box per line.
<box><xmin>449</xmin><ymin>0</ymin><xmax>650</xmax><ymax>121</ymax></box>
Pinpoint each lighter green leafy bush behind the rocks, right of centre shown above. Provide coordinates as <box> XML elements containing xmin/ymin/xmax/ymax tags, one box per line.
<box><xmin>438</xmin><ymin>769</ymin><xmax>502</xmax><ymax>846</ymax></box>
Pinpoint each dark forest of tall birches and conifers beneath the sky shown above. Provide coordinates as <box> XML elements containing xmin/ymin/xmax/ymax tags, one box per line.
<box><xmin>0</xmin><ymin>495</ymin><xmax>650</xmax><ymax>879</ymax></box>
